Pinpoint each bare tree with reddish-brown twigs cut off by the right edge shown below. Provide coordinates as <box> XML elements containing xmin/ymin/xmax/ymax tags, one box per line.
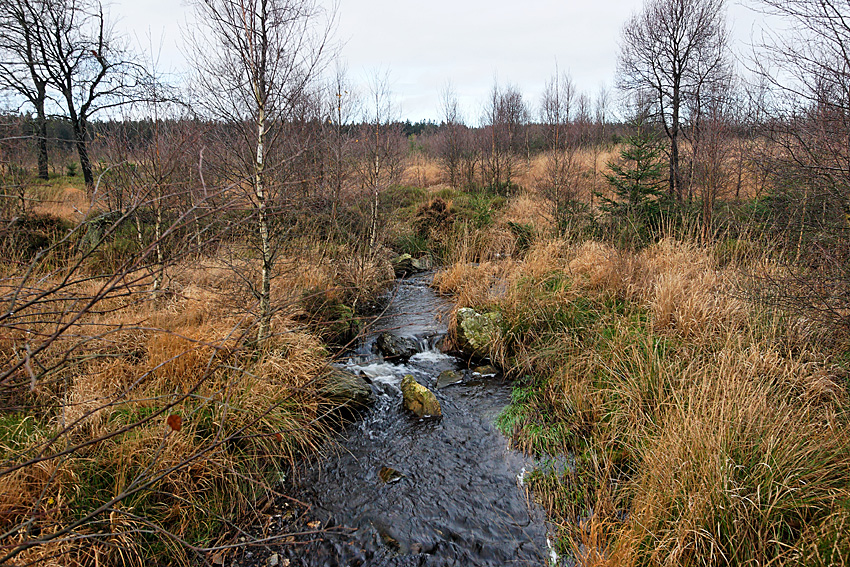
<box><xmin>753</xmin><ymin>0</ymin><xmax>850</xmax><ymax>332</ymax></box>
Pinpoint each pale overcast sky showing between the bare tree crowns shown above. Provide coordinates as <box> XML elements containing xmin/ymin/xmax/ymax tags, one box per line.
<box><xmin>110</xmin><ymin>0</ymin><xmax>761</xmax><ymax>123</ymax></box>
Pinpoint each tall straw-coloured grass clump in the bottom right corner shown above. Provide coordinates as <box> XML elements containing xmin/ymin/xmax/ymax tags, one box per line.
<box><xmin>621</xmin><ymin>352</ymin><xmax>850</xmax><ymax>564</ymax></box>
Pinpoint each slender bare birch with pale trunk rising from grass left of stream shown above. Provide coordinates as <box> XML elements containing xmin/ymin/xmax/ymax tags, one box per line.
<box><xmin>187</xmin><ymin>0</ymin><xmax>328</xmax><ymax>341</ymax></box>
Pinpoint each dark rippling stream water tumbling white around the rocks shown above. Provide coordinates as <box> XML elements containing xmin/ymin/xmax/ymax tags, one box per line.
<box><xmin>286</xmin><ymin>276</ymin><xmax>549</xmax><ymax>566</ymax></box>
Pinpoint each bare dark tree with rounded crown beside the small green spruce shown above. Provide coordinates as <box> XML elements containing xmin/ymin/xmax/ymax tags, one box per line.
<box><xmin>618</xmin><ymin>0</ymin><xmax>728</xmax><ymax>201</ymax></box>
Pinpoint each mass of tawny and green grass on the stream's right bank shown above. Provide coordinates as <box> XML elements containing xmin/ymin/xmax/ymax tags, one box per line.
<box><xmin>435</xmin><ymin>240</ymin><xmax>850</xmax><ymax>565</ymax></box>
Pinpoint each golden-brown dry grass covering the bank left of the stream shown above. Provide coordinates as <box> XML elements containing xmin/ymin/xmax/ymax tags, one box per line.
<box><xmin>0</xmin><ymin>237</ymin><xmax>387</xmax><ymax>565</ymax></box>
